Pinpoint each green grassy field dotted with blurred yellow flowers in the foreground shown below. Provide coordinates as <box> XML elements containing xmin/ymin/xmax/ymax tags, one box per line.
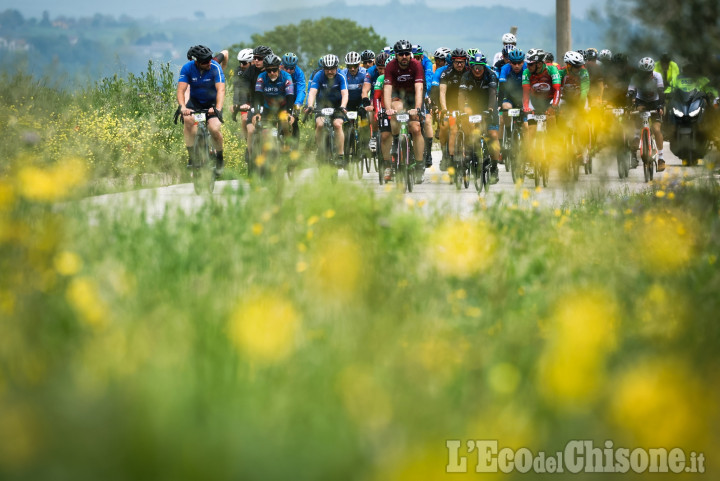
<box><xmin>0</xmin><ymin>65</ymin><xmax>720</xmax><ymax>481</ymax></box>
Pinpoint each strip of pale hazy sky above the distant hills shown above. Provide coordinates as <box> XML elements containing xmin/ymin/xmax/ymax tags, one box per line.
<box><xmin>8</xmin><ymin>0</ymin><xmax>603</xmax><ymax>20</ymax></box>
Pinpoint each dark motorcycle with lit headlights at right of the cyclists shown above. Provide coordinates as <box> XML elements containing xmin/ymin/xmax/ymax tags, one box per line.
<box><xmin>668</xmin><ymin>89</ymin><xmax>710</xmax><ymax>165</ymax></box>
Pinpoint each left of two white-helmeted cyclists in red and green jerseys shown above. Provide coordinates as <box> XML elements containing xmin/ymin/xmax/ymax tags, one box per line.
<box><xmin>523</xmin><ymin>48</ymin><xmax>560</xmax><ymax>172</ymax></box>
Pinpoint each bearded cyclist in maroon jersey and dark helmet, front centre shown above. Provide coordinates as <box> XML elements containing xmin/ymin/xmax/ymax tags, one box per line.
<box><xmin>383</xmin><ymin>40</ymin><xmax>425</xmax><ymax>176</ymax></box>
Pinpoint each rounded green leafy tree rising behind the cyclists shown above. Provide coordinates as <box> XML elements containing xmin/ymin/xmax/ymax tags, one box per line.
<box><xmin>230</xmin><ymin>17</ymin><xmax>387</xmax><ymax>68</ymax></box>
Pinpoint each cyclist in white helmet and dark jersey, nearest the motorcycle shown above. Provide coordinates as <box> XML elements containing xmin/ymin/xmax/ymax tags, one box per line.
<box><xmin>628</xmin><ymin>57</ymin><xmax>665</xmax><ymax>172</ymax></box>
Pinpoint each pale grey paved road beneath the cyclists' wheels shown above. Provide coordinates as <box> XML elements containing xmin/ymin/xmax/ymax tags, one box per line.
<box><xmin>86</xmin><ymin>142</ymin><xmax>706</xmax><ymax>220</ymax></box>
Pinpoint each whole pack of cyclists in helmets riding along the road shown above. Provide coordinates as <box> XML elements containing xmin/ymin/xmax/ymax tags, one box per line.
<box><xmin>177</xmin><ymin>33</ymin><xmax>717</xmax><ymax>183</ymax></box>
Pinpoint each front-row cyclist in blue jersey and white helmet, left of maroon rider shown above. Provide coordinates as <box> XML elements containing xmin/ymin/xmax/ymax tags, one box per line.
<box><xmin>306</xmin><ymin>54</ymin><xmax>348</xmax><ymax>165</ymax></box>
